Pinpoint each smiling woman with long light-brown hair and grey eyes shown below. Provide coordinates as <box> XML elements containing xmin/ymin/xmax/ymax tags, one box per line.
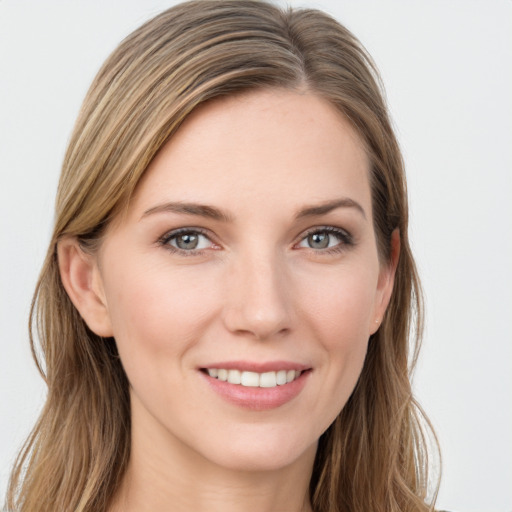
<box><xmin>7</xmin><ymin>0</ymin><xmax>440</xmax><ymax>512</ymax></box>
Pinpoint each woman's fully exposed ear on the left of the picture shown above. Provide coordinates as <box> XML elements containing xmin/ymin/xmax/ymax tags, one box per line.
<box><xmin>57</xmin><ymin>237</ymin><xmax>113</xmax><ymax>337</ymax></box>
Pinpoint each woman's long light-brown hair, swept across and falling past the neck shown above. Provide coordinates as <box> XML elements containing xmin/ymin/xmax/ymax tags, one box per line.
<box><xmin>6</xmin><ymin>0</ymin><xmax>435</xmax><ymax>512</ymax></box>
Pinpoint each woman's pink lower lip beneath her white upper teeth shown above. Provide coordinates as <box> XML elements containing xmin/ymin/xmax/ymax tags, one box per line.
<box><xmin>201</xmin><ymin>370</ymin><xmax>311</xmax><ymax>411</ymax></box>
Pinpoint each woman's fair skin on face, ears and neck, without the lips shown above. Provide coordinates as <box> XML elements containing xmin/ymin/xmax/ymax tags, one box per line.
<box><xmin>59</xmin><ymin>90</ymin><xmax>398</xmax><ymax>512</ymax></box>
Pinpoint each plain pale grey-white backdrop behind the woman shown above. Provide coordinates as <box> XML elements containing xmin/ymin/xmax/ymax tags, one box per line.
<box><xmin>0</xmin><ymin>0</ymin><xmax>512</xmax><ymax>512</ymax></box>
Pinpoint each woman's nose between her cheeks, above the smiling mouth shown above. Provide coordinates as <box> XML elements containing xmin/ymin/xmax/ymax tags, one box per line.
<box><xmin>223</xmin><ymin>249</ymin><xmax>293</xmax><ymax>340</ymax></box>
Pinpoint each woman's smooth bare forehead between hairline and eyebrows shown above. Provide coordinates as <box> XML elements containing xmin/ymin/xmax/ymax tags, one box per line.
<box><xmin>132</xmin><ymin>90</ymin><xmax>371</xmax><ymax>220</ymax></box>
